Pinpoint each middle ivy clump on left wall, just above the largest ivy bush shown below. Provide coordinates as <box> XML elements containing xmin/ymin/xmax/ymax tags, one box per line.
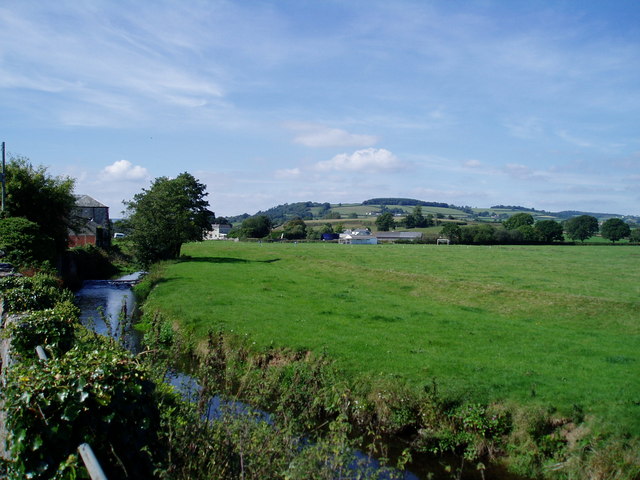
<box><xmin>9</xmin><ymin>300</ymin><xmax>80</xmax><ymax>358</ymax></box>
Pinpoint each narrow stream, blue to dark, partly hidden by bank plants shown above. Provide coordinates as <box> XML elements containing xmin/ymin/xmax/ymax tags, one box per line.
<box><xmin>76</xmin><ymin>273</ymin><xmax>524</xmax><ymax>480</ymax></box>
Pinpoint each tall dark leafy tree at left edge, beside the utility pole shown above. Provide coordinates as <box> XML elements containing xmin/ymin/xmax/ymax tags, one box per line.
<box><xmin>5</xmin><ymin>157</ymin><xmax>76</xmax><ymax>254</ymax></box>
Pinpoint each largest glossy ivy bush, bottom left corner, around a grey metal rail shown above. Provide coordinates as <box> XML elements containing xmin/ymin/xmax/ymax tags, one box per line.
<box><xmin>5</xmin><ymin>337</ymin><xmax>159</xmax><ymax>479</ymax></box>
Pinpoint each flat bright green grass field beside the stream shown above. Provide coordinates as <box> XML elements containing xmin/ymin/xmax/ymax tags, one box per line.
<box><xmin>146</xmin><ymin>242</ymin><xmax>640</xmax><ymax>436</ymax></box>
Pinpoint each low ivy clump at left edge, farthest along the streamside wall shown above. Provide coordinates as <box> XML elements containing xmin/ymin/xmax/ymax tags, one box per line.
<box><xmin>0</xmin><ymin>274</ymin><xmax>73</xmax><ymax>313</ymax></box>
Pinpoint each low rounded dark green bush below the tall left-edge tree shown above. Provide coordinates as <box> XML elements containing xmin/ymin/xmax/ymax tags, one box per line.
<box><xmin>0</xmin><ymin>217</ymin><xmax>55</xmax><ymax>267</ymax></box>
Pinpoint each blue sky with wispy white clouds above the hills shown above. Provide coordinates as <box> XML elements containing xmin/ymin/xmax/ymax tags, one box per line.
<box><xmin>0</xmin><ymin>0</ymin><xmax>640</xmax><ymax>217</ymax></box>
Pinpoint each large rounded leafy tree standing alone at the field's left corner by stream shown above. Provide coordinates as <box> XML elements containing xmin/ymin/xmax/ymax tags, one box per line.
<box><xmin>126</xmin><ymin>172</ymin><xmax>212</xmax><ymax>265</ymax></box>
